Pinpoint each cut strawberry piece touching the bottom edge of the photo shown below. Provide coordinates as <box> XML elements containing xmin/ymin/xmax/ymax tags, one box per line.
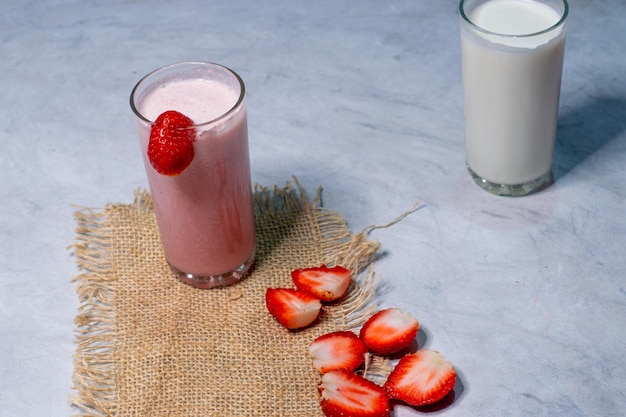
<box><xmin>319</xmin><ymin>371</ymin><xmax>391</xmax><ymax>417</ymax></box>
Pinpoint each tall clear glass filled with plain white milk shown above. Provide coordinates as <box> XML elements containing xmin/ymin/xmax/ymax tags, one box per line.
<box><xmin>459</xmin><ymin>0</ymin><xmax>568</xmax><ymax>196</ymax></box>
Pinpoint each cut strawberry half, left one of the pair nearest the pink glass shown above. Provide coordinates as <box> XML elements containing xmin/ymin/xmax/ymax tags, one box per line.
<box><xmin>265</xmin><ymin>288</ymin><xmax>322</xmax><ymax>329</ymax></box>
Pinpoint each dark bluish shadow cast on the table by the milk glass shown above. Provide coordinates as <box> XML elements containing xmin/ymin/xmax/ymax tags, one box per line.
<box><xmin>553</xmin><ymin>97</ymin><xmax>626</xmax><ymax>181</ymax></box>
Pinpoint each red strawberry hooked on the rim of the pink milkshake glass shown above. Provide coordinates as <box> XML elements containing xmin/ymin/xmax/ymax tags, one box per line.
<box><xmin>148</xmin><ymin>110</ymin><xmax>196</xmax><ymax>176</ymax></box>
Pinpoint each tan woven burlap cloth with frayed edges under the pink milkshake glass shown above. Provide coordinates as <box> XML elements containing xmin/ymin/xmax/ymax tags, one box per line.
<box><xmin>72</xmin><ymin>181</ymin><xmax>388</xmax><ymax>417</ymax></box>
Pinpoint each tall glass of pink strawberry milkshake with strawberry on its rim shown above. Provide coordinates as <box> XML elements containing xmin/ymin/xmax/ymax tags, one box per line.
<box><xmin>130</xmin><ymin>62</ymin><xmax>255</xmax><ymax>288</ymax></box>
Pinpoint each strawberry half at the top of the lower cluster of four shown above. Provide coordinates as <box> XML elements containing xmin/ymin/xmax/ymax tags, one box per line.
<box><xmin>359</xmin><ymin>308</ymin><xmax>419</xmax><ymax>356</ymax></box>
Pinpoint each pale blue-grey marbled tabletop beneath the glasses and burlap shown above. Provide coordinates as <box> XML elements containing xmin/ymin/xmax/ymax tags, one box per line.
<box><xmin>0</xmin><ymin>0</ymin><xmax>626</xmax><ymax>417</ymax></box>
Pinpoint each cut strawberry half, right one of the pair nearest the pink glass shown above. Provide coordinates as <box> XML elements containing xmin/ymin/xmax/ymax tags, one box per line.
<box><xmin>291</xmin><ymin>265</ymin><xmax>350</xmax><ymax>301</ymax></box>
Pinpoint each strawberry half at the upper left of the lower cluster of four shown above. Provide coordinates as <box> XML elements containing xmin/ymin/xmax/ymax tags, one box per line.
<box><xmin>309</xmin><ymin>330</ymin><xmax>367</xmax><ymax>374</ymax></box>
